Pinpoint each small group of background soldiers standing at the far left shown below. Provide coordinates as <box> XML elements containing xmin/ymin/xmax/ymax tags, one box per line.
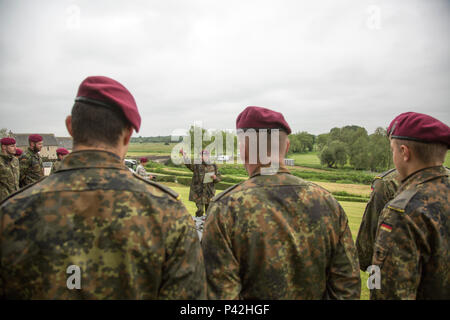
<box><xmin>0</xmin><ymin>134</ymin><xmax>69</xmax><ymax>201</ymax></box>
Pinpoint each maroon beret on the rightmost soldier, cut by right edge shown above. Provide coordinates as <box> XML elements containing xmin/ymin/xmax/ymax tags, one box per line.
<box><xmin>387</xmin><ymin>112</ymin><xmax>450</xmax><ymax>147</ymax></box>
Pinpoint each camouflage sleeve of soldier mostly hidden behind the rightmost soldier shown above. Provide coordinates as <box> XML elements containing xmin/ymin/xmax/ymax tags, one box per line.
<box><xmin>356</xmin><ymin>180</ymin><xmax>391</xmax><ymax>271</ymax></box>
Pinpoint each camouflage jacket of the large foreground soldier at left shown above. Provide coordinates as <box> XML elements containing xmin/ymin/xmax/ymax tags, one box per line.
<box><xmin>0</xmin><ymin>150</ymin><xmax>206</xmax><ymax>299</ymax></box>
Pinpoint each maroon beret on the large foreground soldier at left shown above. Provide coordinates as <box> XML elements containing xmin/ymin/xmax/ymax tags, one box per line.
<box><xmin>75</xmin><ymin>76</ymin><xmax>141</xmax><ymax>132</ymax></box>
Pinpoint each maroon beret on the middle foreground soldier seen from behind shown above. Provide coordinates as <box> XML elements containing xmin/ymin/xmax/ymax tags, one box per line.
<box><xmin>236</xmin><ymin>107</ymin><xmax>291</xmax><ymax>134</ymax></box>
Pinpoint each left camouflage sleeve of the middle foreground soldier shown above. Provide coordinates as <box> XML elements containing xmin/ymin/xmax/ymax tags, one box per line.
<box><xmin>202</xmin><ymin>202</ymin><xmax>242</xmax><ymax>300</ymax></box>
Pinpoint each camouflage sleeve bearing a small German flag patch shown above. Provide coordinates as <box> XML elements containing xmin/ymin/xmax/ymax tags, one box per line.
<box><xmin>371</xmin><ymin>208</ymin><xmax>429</xmax><ymax>299</ymax></box>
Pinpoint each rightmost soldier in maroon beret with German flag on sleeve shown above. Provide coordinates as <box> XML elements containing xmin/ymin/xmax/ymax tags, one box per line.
<box><xmin>371</xmin><ymin>112</ymin><xmax>450</xmax><ymax>299</ymax></box>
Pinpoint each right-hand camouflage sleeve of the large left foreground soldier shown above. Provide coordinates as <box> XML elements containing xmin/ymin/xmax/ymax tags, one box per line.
<box><xmin>159</xmin><ymin>203</ymin><xmax>206</xmax><ymax>300</ymax></box>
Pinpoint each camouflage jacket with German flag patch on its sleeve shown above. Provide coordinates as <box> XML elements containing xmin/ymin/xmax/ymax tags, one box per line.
<box><xmin>371</xmin><ymin>166</ymin><xmax>450</xmax><ymax>299</ymax></box>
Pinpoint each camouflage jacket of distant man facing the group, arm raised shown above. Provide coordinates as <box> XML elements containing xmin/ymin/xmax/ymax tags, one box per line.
<box><xmin>185</xmin><ymin>163</ymin><xmax>220</xmax><ymax>203</ymax></box>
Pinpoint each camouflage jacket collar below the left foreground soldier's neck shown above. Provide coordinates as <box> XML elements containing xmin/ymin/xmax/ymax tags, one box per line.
<box><xmin>58</xmin><ymin>150</ymin><xmax>127</xmax><ymax>171</ymax></box>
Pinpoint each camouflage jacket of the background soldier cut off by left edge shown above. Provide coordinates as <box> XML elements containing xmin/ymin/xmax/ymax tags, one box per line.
<box><xmin>0</xmin><ymin>153</ymin><xmax>20</xmax><ymax>201</ymax></box>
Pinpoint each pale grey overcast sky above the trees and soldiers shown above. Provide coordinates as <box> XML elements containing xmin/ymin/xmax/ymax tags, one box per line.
<box><xmin>0</xmin><ymin>0</ymin><xmax>450</xmax><ymax>136</ymax></box>
